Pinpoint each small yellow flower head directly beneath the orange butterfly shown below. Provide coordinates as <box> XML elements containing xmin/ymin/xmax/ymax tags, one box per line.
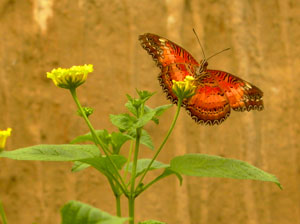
<box><xmin>172</xmin><ymin>75</ymin><xmax>196</xmax><ymax>99</ymax></box>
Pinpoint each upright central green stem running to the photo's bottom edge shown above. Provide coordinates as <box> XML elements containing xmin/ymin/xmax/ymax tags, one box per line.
<box><xmin>128</xmin><ymin>128</ymin><xmax>142</xmax><ymax>224</ymax></box>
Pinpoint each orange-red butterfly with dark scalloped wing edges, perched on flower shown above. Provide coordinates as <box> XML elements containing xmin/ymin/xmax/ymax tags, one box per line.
<box><xmin>139</xmin><ymin>33</ymin><xmax>263</xmax><ymax>125</ymax></box>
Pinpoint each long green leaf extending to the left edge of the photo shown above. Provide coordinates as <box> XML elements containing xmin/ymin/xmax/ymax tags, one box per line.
<box><xmin>0</xmin><ymin>144</ymin><xmax>100</xmax><ymax>161</ymax></box>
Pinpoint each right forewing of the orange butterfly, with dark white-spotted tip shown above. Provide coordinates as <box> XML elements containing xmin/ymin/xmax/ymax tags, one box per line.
<box><xmin>207</xmin><ymin>70</ymin><xmax>263</xmax><ymax>111</ymax></box>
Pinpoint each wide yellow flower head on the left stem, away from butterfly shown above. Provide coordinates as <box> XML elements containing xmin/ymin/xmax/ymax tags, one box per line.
<box><xmin>47</xmin><ymin>65</ymin><xmax>94</xmax><ymax>89</ymax></box>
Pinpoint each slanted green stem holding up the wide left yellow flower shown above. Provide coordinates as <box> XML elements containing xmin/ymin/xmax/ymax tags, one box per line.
<box><xmin>70</xmin><ymin>88</ymin><xmax>127</xmax><ymax>194</ymax></box>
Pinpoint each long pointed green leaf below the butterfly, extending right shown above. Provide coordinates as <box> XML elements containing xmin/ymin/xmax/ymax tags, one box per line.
<box><xmin>171</xmin><ymin>154</ymin><xmax>281</xmax><ymax>188</ymax></box>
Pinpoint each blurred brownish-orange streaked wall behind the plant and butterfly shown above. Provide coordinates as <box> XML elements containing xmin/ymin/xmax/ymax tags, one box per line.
<box><xmin>0</xmin><ymin>0</ymin><xmax>300</xmax><ymax>224</ymax></box>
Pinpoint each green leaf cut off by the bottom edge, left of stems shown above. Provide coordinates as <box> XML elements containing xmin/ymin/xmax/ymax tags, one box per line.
<box><xmin>61</xmin><ymin>201</ymin><xmax>127</xmax><ymax>224</ymax></box>
